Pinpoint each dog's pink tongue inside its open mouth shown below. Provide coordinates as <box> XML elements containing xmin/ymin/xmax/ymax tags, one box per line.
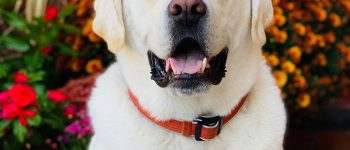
<box><xmin>167</xmin><ymin>53</ymin><xmax>204</xmax><ymax>74</ymax></box>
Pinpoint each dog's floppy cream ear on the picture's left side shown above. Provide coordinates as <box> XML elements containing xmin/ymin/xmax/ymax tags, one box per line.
<box><xmin>93</xmin><ymin>0</ymin><xmax>125</xmax><ymax>53</ymax></box>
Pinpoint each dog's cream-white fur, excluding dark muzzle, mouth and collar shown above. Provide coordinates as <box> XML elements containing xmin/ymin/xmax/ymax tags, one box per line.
<box><xmin>88</xmin><ymin>0</ymin><xmax>286</xmax><ymax>150</ymax></box>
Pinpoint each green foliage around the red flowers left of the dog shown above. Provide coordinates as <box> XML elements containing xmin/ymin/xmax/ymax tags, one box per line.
<box><xmin>0</xmin><ymin>0</ymin><xmax>93</xmax><ymax>150</ymax></box>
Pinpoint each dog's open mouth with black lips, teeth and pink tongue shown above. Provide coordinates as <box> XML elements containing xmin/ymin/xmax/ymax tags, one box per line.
<box><xmin>148</xmin><ymin>38</ymin><xmax>228</xmax><ymax>88</ymax></box>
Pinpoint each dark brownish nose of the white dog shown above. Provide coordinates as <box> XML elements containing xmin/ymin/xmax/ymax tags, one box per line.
<box><xmin>168</xmin><ymin>0</ymin><xmax>207</xmax><ymax>25</ymax></box>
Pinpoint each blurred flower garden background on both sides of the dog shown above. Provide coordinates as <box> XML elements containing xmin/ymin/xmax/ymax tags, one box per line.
<box><xmin>0</xmin><ymin>0</ymin><xmax>350</xmax><ymax>150</ymax></box>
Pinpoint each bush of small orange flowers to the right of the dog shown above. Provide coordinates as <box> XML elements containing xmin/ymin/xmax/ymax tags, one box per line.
<box><xmin>264</xmin><ymin>0</ymin><xmax>350</xmax><ymax>121</ymax></box>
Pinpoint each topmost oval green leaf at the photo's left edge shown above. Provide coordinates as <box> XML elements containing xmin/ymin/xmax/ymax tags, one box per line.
<box><xmin>0</xmin><ymin>10</ymin><xmax>27</xmax><ymax>29</ymax></box>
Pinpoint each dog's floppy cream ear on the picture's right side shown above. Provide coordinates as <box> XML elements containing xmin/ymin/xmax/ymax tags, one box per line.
<box><xmin>251</xmin><ymin>0</ymin><xmax>273</xmax><ymax>46</ymax></box>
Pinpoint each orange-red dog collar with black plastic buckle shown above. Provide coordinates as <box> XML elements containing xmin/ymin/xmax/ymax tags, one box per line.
<box><xmin>128</xmin><ymin>90</ymin><xmax>248</xmax><ymax>141</ymax></box>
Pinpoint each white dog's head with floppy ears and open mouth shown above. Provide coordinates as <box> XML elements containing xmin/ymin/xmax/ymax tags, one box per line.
<box><xmin>93</xmin><ymin>0</ymin><xmax>273</xmax><ymax>95</ymax></box>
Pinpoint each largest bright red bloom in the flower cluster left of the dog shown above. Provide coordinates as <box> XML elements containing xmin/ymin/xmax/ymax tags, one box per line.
<box><xmin>8</xmin><ymin>84</ymin><xmax>36</xmax><ymax>108</ymax></box>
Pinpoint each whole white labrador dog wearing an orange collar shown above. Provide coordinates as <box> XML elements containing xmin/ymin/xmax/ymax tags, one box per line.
<box><xmin>88</xmin><ymin>0</ymin><xmax>286</xmax><ymax>150</ymax></box>
